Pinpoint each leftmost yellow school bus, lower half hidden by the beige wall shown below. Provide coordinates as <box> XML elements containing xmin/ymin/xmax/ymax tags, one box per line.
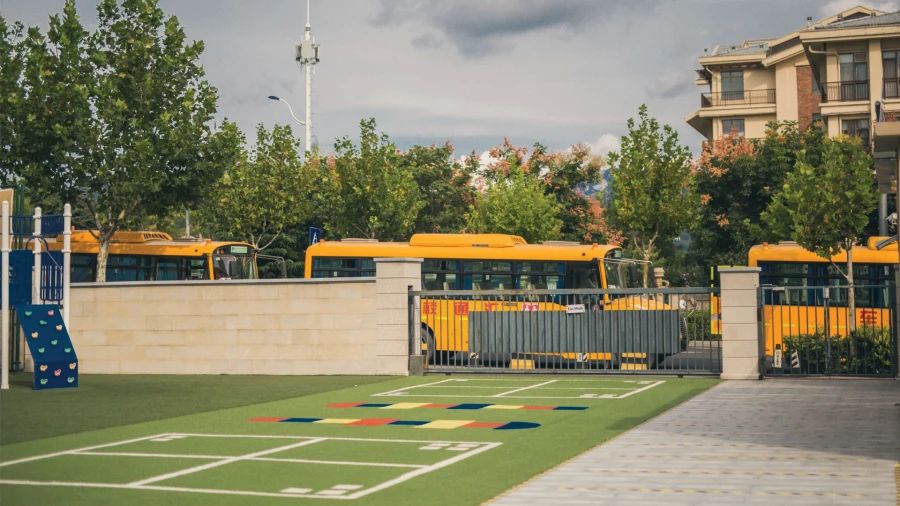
<box><xmin>47</xmin><ymin>230</ymin><xmax>259</xmax><ymax>283</ymax></box>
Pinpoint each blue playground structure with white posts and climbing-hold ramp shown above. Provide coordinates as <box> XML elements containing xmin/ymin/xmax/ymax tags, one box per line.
<box><xmin>0</xmin><ymin>187</ymin><xmax>78</xmax><ymax>390</ymax></box>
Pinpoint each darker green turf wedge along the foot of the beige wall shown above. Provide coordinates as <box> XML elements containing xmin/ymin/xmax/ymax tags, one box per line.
<box><xmin>0</xmin><ymin>373</ymin><xmax>391</xmax><ymax>445</ymax></box>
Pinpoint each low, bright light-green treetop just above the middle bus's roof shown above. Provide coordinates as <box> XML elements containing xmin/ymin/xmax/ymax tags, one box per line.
<box><xmin>469</xmin><ymin>164</ymin><xmax>563</xmax><ymax>243</ymax></box>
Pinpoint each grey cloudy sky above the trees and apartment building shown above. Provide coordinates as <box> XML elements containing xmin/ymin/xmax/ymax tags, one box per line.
<box><xmin>0</xmin><ymin>0</ymin><xmax>897</xmax><ymax>155</ymax></box>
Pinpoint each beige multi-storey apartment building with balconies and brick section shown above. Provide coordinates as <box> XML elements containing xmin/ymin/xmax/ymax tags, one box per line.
<box><xmin>685</xmin><ymin>6</ymin><xmax>900</xmax><ymax>144</ymax></box>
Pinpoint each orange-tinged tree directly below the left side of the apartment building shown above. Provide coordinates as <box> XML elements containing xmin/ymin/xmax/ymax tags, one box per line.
<box><xmin>691</xmin><ymin>121</ymin><xmax>825</xmax><ymax>265</ymax></box>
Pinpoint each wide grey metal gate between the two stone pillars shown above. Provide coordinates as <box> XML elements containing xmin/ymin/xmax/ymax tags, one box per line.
<box><xmin>409</xmin><ymin>288</ymin><xmax>721</xmax><ymax>375</ymax></box>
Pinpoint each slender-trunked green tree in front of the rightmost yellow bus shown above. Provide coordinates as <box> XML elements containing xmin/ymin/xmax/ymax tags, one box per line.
<box><xmin>763</xmin><ymin>136</ymin><xmax>878</xmax><ymax>332</ymax></box>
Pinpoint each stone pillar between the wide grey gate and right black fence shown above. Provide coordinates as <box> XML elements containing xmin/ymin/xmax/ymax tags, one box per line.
<box><xmin>719</xmin><ymin>267</ymin><xmax>760</xmax><ymax>380</ymax></box>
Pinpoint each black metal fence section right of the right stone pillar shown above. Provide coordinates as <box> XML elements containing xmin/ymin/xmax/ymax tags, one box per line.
<box><xmin>758</xmin><ymin>284</ymin><xmax>897</xmax><ymax>377</ymax></box>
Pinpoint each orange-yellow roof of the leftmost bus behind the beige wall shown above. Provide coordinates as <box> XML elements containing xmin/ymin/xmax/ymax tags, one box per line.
<box><xmin>47</xmin><ymin>230</ymin><xmax>253</xmax><ymax>256</ymax></box>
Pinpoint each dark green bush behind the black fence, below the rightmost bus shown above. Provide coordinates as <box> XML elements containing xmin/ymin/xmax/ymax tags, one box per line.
<box><xmin>782</xmin><ymin>325</ymin><xmax>892</xmax><ymax>374</ymax></box>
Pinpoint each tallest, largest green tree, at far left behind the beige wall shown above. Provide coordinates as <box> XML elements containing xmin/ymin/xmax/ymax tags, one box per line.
<box><xmin>0</xmin><ymin>0</ymin><xmax>241</xmax><ymax>281</ymax></box>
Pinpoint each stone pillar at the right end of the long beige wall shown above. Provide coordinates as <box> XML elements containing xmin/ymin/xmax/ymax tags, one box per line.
<box><xmin>375</xmin><ymin>258</ymin><xmax>422</xmax><ymax>376</ymax></box>
